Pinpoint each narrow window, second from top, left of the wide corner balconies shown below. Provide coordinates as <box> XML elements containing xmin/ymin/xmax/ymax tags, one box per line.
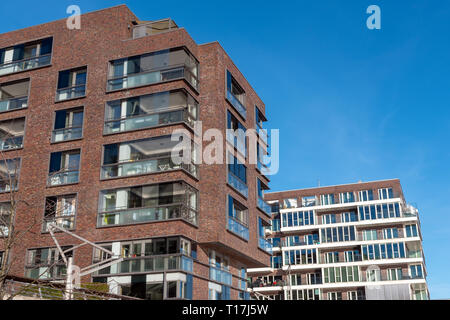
<box><xmin>52</xmin><ymin>107</ymin><xmax>83</xmax><ymax>142</ymax></box>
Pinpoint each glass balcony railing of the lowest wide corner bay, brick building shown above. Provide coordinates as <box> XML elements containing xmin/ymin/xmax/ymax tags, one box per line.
<box><xmin>94</xmin><ymin>254</ymin><xmax>193</xmax><ymax>276</ymax></box>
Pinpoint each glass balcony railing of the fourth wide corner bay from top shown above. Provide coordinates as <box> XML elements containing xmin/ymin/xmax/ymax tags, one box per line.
<box><xmin>97</xmin><ymin>204</ymin><xmax>197</xmax><ymax>227</ymax></box>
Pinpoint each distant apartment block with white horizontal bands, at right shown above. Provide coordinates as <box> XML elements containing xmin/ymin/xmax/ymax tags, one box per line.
<box><xmin>248</xmin><ymin>179</ymin><xmax>429</xmax><ymax>300</ymax></box>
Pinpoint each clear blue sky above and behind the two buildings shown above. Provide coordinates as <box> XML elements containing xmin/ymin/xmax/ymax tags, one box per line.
<box><xmin>0</xmin><ymin>0</ymin><xmax>450</xmax><ymax>299</ymax></box>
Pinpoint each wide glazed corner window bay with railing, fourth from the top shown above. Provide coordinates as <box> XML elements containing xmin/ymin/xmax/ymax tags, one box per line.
<box><xmin>97</xmin><ymin>182</ymin><xmax>198</xmax><ymax>227</ymax></box>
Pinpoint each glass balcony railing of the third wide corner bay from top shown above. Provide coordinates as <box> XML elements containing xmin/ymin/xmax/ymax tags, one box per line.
<box><xmin>102</xmin><ymin>157</ymin><xmax>198</xmax><ymax>179</ymax></box>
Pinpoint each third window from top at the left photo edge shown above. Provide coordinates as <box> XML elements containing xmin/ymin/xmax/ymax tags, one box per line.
<box><xmin>0</xmin><ymin>118</ymin><xmax>25</xmax><ymax>151</ymax></box>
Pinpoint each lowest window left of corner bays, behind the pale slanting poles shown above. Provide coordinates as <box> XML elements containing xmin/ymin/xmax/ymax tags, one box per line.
<box><xmin>25</xmin><ymin>246</ymin><xmax>73</xmax><ymax>279</ymax></box>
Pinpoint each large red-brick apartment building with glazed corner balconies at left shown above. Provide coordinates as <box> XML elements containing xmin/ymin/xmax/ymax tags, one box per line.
<box><xmin>0</xmin><ymin>5</ymin><xmax>271</xmax><ymax>299</ymax></box>
